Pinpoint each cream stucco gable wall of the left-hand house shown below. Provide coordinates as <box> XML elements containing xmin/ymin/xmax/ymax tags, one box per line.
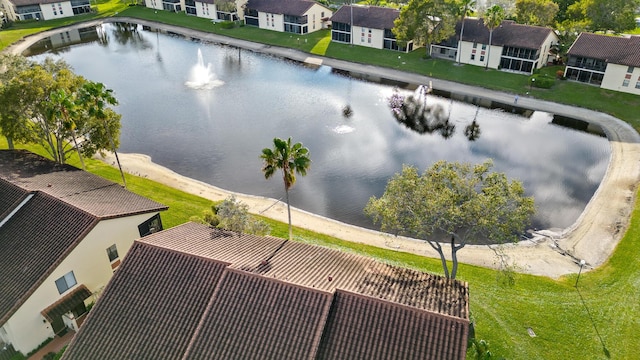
<box><xmin>4</xmin><ymin>213</ymin><xmax>160</xmax><ymax>354</ymax></box>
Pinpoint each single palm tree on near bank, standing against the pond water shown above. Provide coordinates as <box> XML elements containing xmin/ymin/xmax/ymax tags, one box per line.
<box><xmin>260</xmin><ymin>138</ymin><xmax>311</xmax><ymax>240</ymax></box>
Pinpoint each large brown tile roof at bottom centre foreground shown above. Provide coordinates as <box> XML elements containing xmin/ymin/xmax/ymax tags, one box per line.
<box><xmin>65</xmin><ymin>223</ymin><xmax>469</xmax><ymax>359</ymax></box>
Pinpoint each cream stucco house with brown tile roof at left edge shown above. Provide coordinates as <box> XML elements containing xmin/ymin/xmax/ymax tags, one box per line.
<box><xmin>0</xmin><ymin>150</ymin><xmax>166</xmax><ymax>353</ymax></box>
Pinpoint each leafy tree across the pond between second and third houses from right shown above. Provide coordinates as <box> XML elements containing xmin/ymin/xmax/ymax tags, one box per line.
<box><xmin>392</xmin><ymin>0</ymin><xmax>458</xmax><ymax>55</ymax></box>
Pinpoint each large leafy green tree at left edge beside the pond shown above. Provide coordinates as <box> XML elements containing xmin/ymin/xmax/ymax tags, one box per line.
<box><xmin>0</xmin><ymin>58</ymin><xmax>120</xmax><ymax>164</ymax></box>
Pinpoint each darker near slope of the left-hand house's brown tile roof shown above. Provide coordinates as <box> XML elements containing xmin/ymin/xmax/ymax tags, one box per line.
<box><xmin>0</xmin><ymin>193</ymin><xmax>98</xmax><ymax>324</ymax></box>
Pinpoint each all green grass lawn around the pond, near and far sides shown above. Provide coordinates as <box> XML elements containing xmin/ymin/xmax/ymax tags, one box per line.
<box><xmin>0</xmin><ymin>4</ymin><xmax>640</xmax><ymax>359</ymax></box>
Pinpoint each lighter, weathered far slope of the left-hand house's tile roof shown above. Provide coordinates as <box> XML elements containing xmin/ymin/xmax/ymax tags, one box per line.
<box><xmin>0</xmin><ymin>150</ymin><xmax>167</xmax><ymax>219</ymax></box>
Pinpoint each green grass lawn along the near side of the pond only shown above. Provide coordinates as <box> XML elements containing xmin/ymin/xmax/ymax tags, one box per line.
<box><xmin>0</xmin><ymin>139</ymin><xmax>640</xmax><ymax>359</ymax></box>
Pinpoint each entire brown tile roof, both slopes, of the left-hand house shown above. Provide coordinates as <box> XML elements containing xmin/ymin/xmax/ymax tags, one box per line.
<box><xmin>0</xmin><ymin>150</ymin><xmax>166</xmax><ymax>324</ymax></box>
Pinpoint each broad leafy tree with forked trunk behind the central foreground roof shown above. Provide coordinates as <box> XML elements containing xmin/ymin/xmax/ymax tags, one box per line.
<box><xmin>364</xmin><ymin>160</ymin><xmax>535</xmax><ymax>279</ymax></box>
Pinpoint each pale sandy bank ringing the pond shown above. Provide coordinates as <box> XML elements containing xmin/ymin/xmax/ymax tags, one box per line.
<box><xmin>7</xmin><ymin>18</ymin><xmax>640</xmax><ymax>278</ymax></box>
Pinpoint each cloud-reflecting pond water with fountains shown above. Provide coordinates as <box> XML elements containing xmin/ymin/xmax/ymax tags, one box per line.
<box><xmin>25</xmin><ymin>24</ymin><xmax>610</xmax><ymax>229</ymax></box>
